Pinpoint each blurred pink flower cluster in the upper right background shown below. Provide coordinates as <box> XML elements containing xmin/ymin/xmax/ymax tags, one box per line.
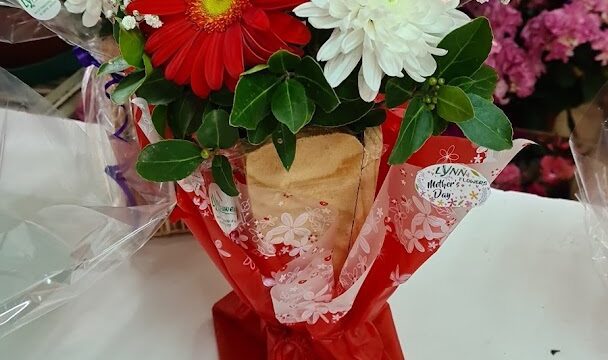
<box><xmin>466</xmin><ymin>0</ymin><xmax>608</xmax><ymax>130</ymax></box>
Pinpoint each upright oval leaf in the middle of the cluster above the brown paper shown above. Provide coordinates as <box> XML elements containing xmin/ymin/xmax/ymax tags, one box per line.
<box><xmin>271</xmin><ymin>79</ymin><xmax>311</xmax><ymax>134</ymax></box>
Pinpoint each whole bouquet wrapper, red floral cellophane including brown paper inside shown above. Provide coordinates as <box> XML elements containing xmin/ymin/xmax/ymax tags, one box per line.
<box><xmin>134</xmin><ymin>107</ymin><xmax>527</xmax><ymax>360</ymax></box>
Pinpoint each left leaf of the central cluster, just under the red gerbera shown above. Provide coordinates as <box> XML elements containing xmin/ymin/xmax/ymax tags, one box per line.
<box><xmin>230</xmin><ymin>73</ymin><xmax>281</xmax><ymax>130</ymax></box>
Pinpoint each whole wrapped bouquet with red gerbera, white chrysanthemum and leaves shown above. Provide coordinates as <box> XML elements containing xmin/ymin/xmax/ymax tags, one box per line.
<box><xmin>13</xmin><ymin>0</ymin><xmax>527</xmax><ymax>359</ymax></box>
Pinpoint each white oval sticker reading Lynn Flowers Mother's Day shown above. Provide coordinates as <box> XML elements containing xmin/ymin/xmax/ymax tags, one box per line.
<box><xmin>416</xmin><ymin>164</ymin><xmax>491</xmax><ymax>207</ymax></box>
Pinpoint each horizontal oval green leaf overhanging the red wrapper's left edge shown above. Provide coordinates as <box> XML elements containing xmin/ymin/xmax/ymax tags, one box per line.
<box><xmin>136</xmin><ymin>140</ymin><xmax>203</xmax><ymax>182</ymax></box>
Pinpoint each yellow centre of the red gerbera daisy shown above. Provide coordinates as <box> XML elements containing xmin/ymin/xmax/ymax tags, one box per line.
<box><xmin>186</xmin><ymin>0</ymin><xmax>251</xmax><ymax>32</ymax></box>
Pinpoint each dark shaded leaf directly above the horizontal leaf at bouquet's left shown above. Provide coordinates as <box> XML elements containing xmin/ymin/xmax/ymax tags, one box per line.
<box><xmin>169</xmin><ymin>93</ymin><xmax>205</xmax><ymax>139</ymax></box>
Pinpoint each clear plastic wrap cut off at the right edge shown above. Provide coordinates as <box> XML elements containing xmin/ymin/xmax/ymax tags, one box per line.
<box><xmin>570</xmin><ymin>85</ymin><xmax>608</xmax><ymax>284</ymax></box>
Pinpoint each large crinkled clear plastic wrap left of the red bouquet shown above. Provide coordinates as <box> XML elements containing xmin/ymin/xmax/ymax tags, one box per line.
<box><xmin>0</xmin><ymin>69</ymin><xmax>175</xmax><ymax>337</ymax></box>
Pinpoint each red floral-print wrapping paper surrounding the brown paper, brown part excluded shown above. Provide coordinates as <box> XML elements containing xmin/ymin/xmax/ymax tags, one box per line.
<box><xmin>133</xmin><ymin>107</ymin><xmax>527</xmax><ymax>360</ymax></box>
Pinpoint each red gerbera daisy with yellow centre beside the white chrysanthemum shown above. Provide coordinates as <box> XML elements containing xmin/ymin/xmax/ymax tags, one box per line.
<box><xmin>127</xmin><ymin>0</ymin><xmax>310</xmax><ymax>97</ymax></box>
